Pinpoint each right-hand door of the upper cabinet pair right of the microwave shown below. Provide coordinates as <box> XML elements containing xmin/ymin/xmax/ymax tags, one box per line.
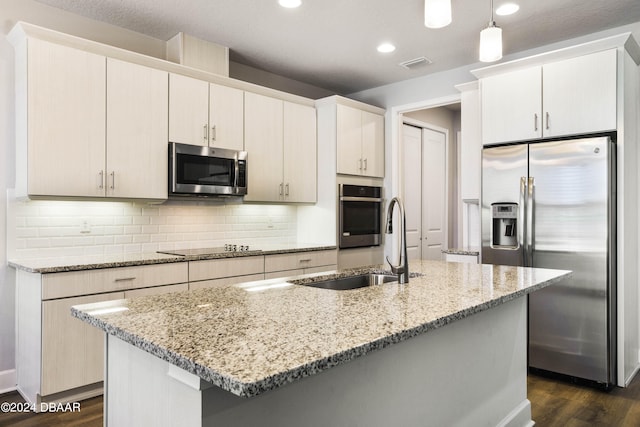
<box><xmin>283</xmin><ymin>102</ymin><xmax>318</xmax><ymax>203</ymax></box>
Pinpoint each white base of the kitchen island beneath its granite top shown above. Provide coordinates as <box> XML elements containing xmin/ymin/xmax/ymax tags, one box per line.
<box><xmin>107</xmin><ymin>298</ymin><xmax>532</xmax><ymax>427</ymax></box>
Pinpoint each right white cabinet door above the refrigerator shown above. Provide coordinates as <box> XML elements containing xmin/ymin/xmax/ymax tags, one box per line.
<box><xmin>543</xmin><ymin>49</ymin><xmax>617</xmax><ymax>137</ymax></box>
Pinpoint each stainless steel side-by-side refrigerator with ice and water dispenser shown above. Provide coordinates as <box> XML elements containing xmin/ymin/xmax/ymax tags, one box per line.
<box><xmin>482</xmin><ymin>137</ymin><xmax>616</xmax><ymax>387</ymax></box>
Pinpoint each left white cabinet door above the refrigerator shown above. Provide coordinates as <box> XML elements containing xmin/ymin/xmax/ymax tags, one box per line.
<box><xmin>480</xmin><ymin>67</ymin><xmax>542</xmax><ymax>145</ymax></box>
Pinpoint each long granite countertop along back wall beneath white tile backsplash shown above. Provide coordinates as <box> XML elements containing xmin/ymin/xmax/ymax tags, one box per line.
<box><xmin>7</xmin><ymin>243</ymin><xmax>336</xmax><ymax>273</ymax></box>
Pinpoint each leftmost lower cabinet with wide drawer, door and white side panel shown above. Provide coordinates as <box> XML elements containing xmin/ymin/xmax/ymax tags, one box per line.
<box><xmin>16</xmin><ymin>262</ymin><xmax>188</xmax><ymax>404</ymax></box>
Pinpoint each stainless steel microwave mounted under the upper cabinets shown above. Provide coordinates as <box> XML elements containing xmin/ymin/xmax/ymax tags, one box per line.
<box><xmin>169</xmin><ymin>142</ymin><xmax>247</xmax><ymax>196</ymax></box>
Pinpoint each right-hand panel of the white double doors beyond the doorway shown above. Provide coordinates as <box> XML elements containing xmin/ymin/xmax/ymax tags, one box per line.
<box><xmin>422</xmin><ymin>128</ymin><xmax>447</xmax><ymax>260</ymax></box>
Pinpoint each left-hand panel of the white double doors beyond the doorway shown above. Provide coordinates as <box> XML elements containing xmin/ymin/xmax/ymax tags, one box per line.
<box><xmin>402</xmin><ymin>124</ymin><xmax>422</xmax><ymax>259</ymax></box>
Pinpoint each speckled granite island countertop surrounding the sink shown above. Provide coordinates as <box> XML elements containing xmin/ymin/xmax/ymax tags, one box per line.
<box><xmin>72</xmin><ymin>261</ymin><xmax>571</xmax><ymax>397</ymax></box>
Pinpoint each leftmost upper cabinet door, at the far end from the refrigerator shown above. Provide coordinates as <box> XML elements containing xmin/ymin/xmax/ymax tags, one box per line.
<box><xmin>25</xmin><ymin>39</ymin><xmax>106</xmax><ymax>197</ymax></box>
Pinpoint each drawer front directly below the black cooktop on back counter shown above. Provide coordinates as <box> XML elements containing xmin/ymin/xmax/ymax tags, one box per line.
<box><xmin>189</xmin><ymin>256</ymin><xmax>264</xmax><ymax>282</ymax></box>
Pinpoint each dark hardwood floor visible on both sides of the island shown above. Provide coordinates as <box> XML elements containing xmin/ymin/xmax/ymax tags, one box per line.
<box><xmin>0</xmin><ymin>375</ymin><xmax>640</xmax><ymax>427</ymax></box>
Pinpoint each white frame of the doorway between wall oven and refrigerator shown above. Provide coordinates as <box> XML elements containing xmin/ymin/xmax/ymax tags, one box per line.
<box><xmin>385</xmin><ymin>93</ymin><xmax>462</xmax><ymax>256</ymax></box>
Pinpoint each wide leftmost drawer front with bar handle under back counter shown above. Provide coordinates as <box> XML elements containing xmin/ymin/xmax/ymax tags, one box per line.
<box><xmin>42</xmin><ymin>262</ymin><xmax>189</xmax><ymax>300</ymax></box>
